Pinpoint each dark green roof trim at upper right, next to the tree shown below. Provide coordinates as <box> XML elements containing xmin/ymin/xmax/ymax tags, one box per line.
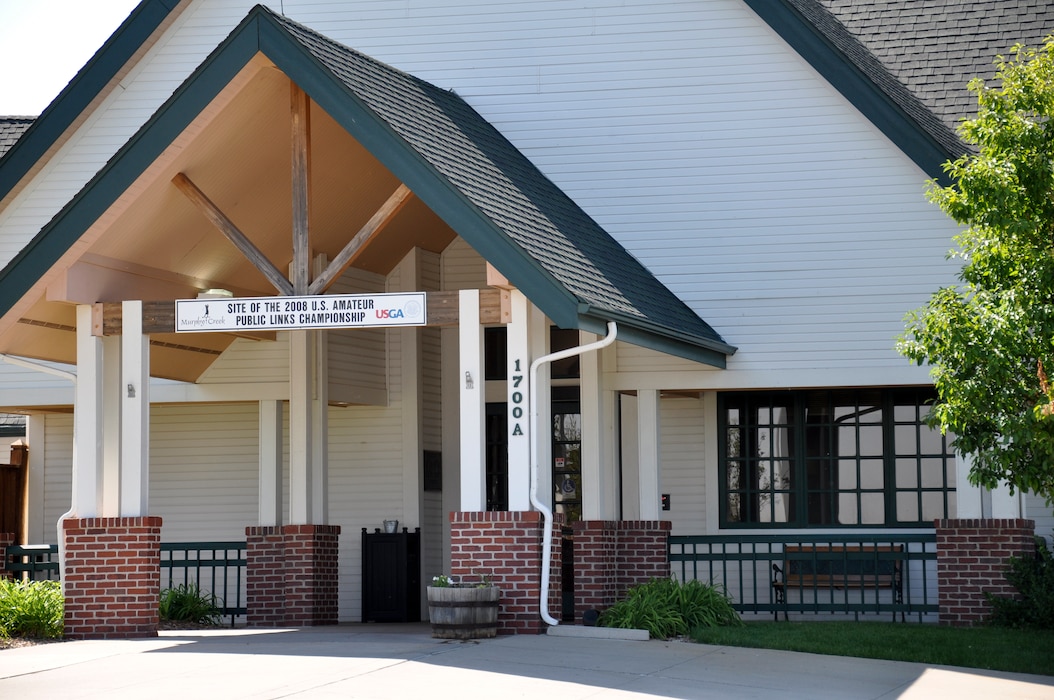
<box><xmin>743</xmin><ymin>0</ymin><xmax>965</xmax><ymax>184</ymax></box>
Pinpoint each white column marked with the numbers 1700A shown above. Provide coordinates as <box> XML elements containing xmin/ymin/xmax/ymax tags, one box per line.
<box><xmin>506</xmin><ymin>289</ymin><xmax>531</xmax><ymax>511</ymax></box>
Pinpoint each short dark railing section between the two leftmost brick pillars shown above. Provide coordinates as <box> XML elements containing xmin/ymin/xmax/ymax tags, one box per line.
<box><xmin>161</xmin><ymin>542</ymin><xmax>246</xmax><ymax>627</ymax></box>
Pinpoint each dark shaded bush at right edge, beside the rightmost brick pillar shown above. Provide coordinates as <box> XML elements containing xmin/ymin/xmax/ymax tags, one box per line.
<box><xmin>984</xmin><ymin>537</ymin><xmax>1054</xmax><ymax>629</ymax></box>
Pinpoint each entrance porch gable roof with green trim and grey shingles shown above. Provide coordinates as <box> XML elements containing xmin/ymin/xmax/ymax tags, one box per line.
<box><xmin>0</xmin><ymin>6</ymin><xmax>735</xmax><ymax>367</ymax></box>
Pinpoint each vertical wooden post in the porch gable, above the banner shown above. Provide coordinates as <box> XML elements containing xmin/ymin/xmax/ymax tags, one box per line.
<box><xmin>289</xmin><ymin>82</ymin><xmax>311</xmax><ymax>296</ymax></box>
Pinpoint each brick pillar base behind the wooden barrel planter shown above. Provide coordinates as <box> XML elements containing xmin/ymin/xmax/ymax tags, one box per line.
<box><xmin>446</xmin><ymin>511</ymin><xmax>561</xmax><ymax>635</ymax></box>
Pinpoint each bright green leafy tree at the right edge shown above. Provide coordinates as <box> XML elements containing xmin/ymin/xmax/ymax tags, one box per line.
<box><xmin>897</xmin><ymin>37</ymin><xmax>1054</xmax><ymax>501</ymax></box>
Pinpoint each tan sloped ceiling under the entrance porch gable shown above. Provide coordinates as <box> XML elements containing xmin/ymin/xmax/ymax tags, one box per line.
<box><xmin>0</xmin><ymin>55</ymin><xmax>455</xmax><ymax>382</ymax></box>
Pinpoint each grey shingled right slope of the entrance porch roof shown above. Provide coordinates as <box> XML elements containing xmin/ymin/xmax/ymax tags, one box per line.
<box><xmin>267</xmin><ymin>8</ymin><xmax>734</xmax><ymax>352</ymax></box>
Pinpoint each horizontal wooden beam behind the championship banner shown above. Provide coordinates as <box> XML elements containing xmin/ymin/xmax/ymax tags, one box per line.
<box><xmin>92</xmin><ymin>289</ymin><xmax>508</xmax><ymax>339</ymax></box>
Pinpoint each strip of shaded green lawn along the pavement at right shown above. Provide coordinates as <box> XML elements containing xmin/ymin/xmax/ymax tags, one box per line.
<box><xmin>691</xmin><ymin>622</ymin><xmax>1054</xmax><ymax>676</ymax></box>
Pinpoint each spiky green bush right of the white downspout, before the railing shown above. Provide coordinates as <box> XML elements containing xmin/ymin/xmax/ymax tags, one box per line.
<box><xmin>598</xmin><ymin>579</ymin><xmax>743</xmax><ymax>639</ymax></box>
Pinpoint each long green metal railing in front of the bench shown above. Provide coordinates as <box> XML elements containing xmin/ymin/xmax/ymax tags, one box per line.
<box><xmin>668</xmin><ymin>533</ymin><xmax>939</xmax><ymax>622</ymax></box>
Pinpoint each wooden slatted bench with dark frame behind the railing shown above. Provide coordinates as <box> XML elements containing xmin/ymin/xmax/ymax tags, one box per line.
<box><xmin>773</xmin><ymin>544</ymin><xmax>904</xmax><ymax>622</ymax></box>
